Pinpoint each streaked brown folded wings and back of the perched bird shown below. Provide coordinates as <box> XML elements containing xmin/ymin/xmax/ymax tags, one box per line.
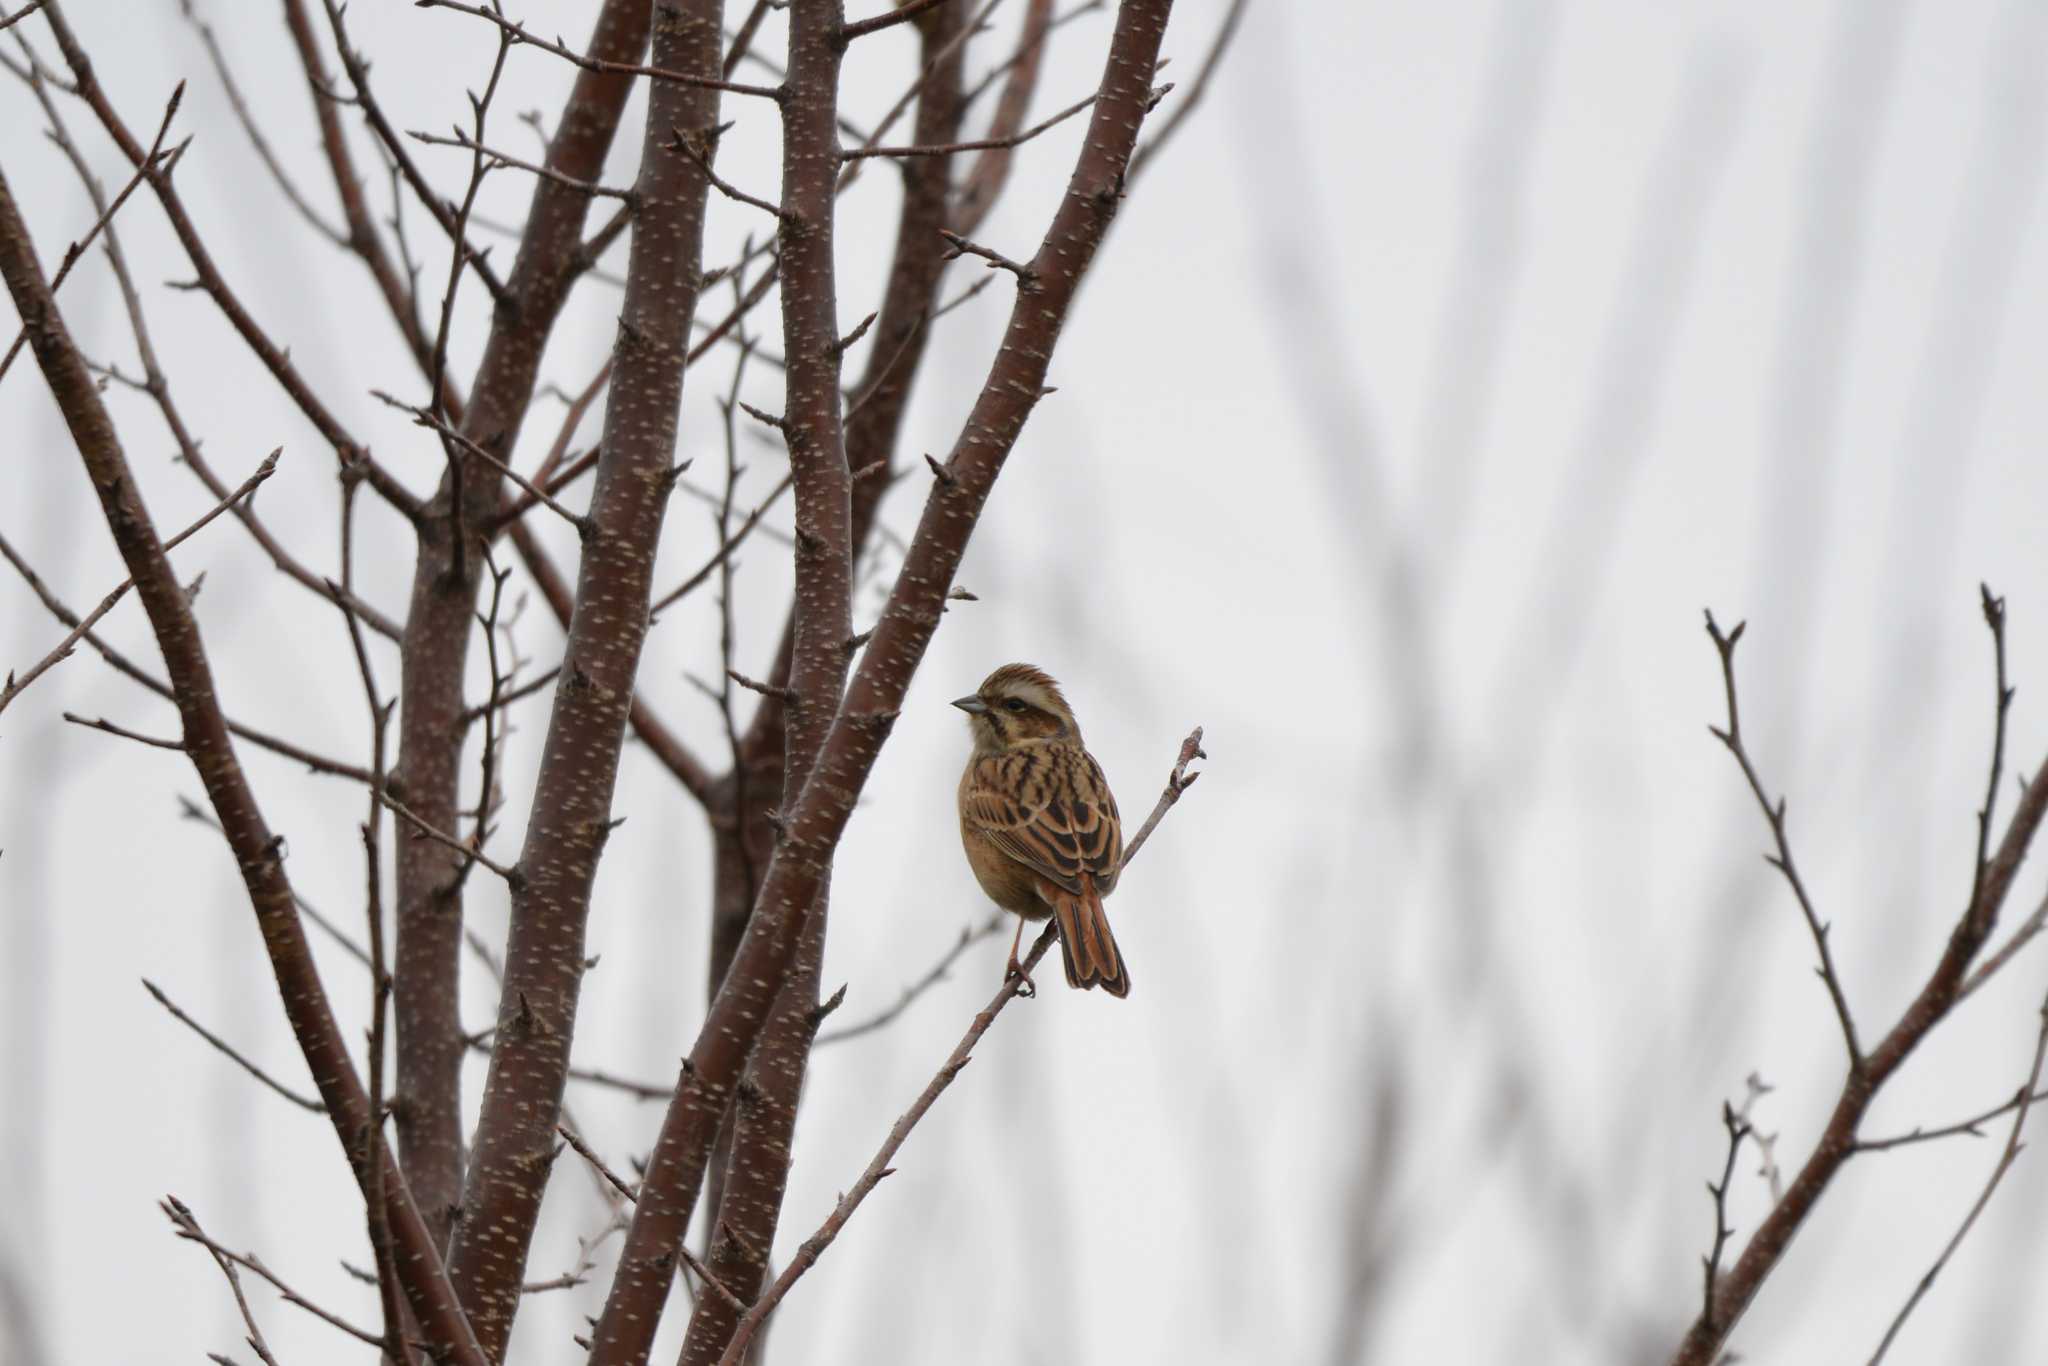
<box><xmin>965</xmin><ymin>745</ymin><xmax>1124</xmax><ymax>895</ymax></box>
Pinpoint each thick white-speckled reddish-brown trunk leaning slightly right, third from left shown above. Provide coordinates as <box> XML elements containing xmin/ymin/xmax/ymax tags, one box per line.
<box><xmin>451</xmin><ymin>0</ymin><xmax>721</xmax><ymax>1358</ymax></box>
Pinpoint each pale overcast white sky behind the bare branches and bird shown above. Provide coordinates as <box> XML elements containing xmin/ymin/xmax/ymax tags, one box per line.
<box><xmin>0</xmin><ymin>0</ymin><xmax>2048</xmax><ymax>1364</ymax></box>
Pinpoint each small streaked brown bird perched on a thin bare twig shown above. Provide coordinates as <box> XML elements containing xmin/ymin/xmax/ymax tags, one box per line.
<box><xmin>952</xmin><ymin>664</ymin><xmax>1130</xmax><ymax>997</ymax></box>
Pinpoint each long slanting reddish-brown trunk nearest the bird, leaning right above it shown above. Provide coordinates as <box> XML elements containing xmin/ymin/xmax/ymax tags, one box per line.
<box><xmin>592</xmin><ymin>0</ymin><xmax>1171</xmax><ymax>1366</ymax></box>
